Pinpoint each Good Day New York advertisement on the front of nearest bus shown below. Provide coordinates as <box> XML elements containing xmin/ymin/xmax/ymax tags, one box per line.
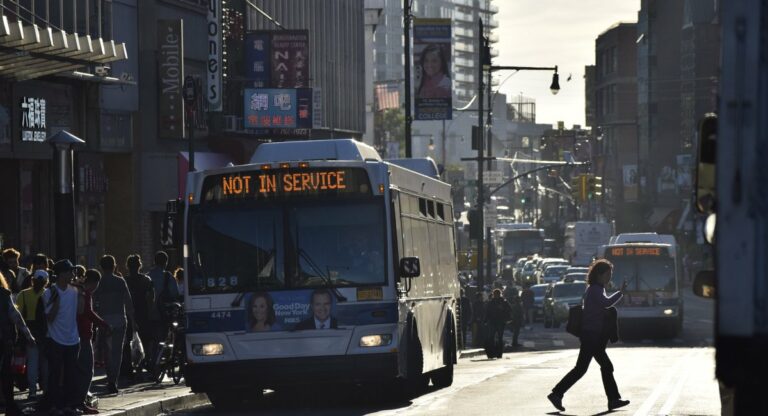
<box><xmin>245</xmin><ymin>288</ymin><xmax>338</xmax><ymax>332</ymax></box>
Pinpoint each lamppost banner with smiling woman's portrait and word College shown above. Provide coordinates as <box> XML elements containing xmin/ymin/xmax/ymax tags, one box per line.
<box><xmin>413</xmin><ymin>19</ymin><xmax>453</xmax><ymax>120</ymax></box>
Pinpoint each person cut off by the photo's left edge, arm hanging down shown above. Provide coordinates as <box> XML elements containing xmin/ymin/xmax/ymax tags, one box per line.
<box><xmin>0</xmin><ymin>266</ymin><xmax>35</xmax><ymax>415</ymax></box>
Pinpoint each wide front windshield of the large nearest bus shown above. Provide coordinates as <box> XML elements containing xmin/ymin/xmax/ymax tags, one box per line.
<box><xmin>189</xmin><ymin>199</ymin><xmax>386</xmax><ymax>295</ymax></box>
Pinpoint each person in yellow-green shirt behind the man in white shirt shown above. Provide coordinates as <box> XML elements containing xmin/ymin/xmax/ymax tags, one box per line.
<box><xmin>16</xmin><ymin>269</ymin><xmax>48</xmax><ymax>399</ymax></box>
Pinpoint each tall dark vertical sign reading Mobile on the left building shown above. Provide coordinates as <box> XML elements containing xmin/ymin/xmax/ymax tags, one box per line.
<box><xmin>157</xmin><ymin>19</ymin><xmax>185</xmax><ymax>139</ymax></box>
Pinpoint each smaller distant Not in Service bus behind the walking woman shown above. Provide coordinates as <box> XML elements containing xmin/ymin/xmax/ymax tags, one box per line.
<box><xmin>599</xmin><ymin>233</ymin><xmax>684</xmax><ymax>336</ymax></box>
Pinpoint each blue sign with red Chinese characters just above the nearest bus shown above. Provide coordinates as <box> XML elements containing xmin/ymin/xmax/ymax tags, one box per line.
<box><xmin>243</xmin><ymin>88</ymin><xmax>312</xmax><ymax>129</ymax></box>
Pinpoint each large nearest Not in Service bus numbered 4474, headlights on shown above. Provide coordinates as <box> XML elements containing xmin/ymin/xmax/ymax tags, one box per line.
<box><xmin>184</xmin><ymin>139</ymin><xmax>459</xmax><ymax>408</ymax></box>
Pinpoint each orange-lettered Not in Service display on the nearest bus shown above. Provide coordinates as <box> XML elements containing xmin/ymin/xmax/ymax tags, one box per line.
<box><xmin>203</xmin><ymin>168</ymin><xmax>371</xmax><ymax>202</ymax></box>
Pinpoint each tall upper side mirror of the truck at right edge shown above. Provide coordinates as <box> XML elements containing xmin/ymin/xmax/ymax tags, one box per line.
<box><xmin>695</xmin><ymin>113</ymin><xmax>717</xmax><ymax>214</ymax></box>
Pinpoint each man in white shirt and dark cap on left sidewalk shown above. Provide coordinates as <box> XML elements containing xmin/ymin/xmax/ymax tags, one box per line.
<box><xmin>43</xmin><ymin>260</ymin><xmax>82</xmax><ymax>414</ymax></box>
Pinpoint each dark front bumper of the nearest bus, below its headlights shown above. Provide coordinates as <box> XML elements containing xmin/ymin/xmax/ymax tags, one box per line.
<box><xmin>184</xmin><ymin>353</ymin><xmax>397</xmax><ymax>392</ymax></box>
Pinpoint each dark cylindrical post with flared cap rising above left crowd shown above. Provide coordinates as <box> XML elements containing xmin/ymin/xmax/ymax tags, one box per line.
<box><xmin>48</xmin><ymin>130</ymin><xmax>85</xmax><ymax>262</ymax></box>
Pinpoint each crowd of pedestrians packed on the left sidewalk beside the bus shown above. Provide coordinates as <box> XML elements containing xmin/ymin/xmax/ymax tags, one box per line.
<box><xmin>0</xmin><ymin>248</ymin><xmax>183</xmax><ymax>415</ymax></box>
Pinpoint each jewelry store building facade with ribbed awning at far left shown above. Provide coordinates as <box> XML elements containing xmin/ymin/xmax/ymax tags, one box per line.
<box><xmin>0</xmin><ymin>0</ymin><xmax>131</xmax><ymax>264</ymax></box>
